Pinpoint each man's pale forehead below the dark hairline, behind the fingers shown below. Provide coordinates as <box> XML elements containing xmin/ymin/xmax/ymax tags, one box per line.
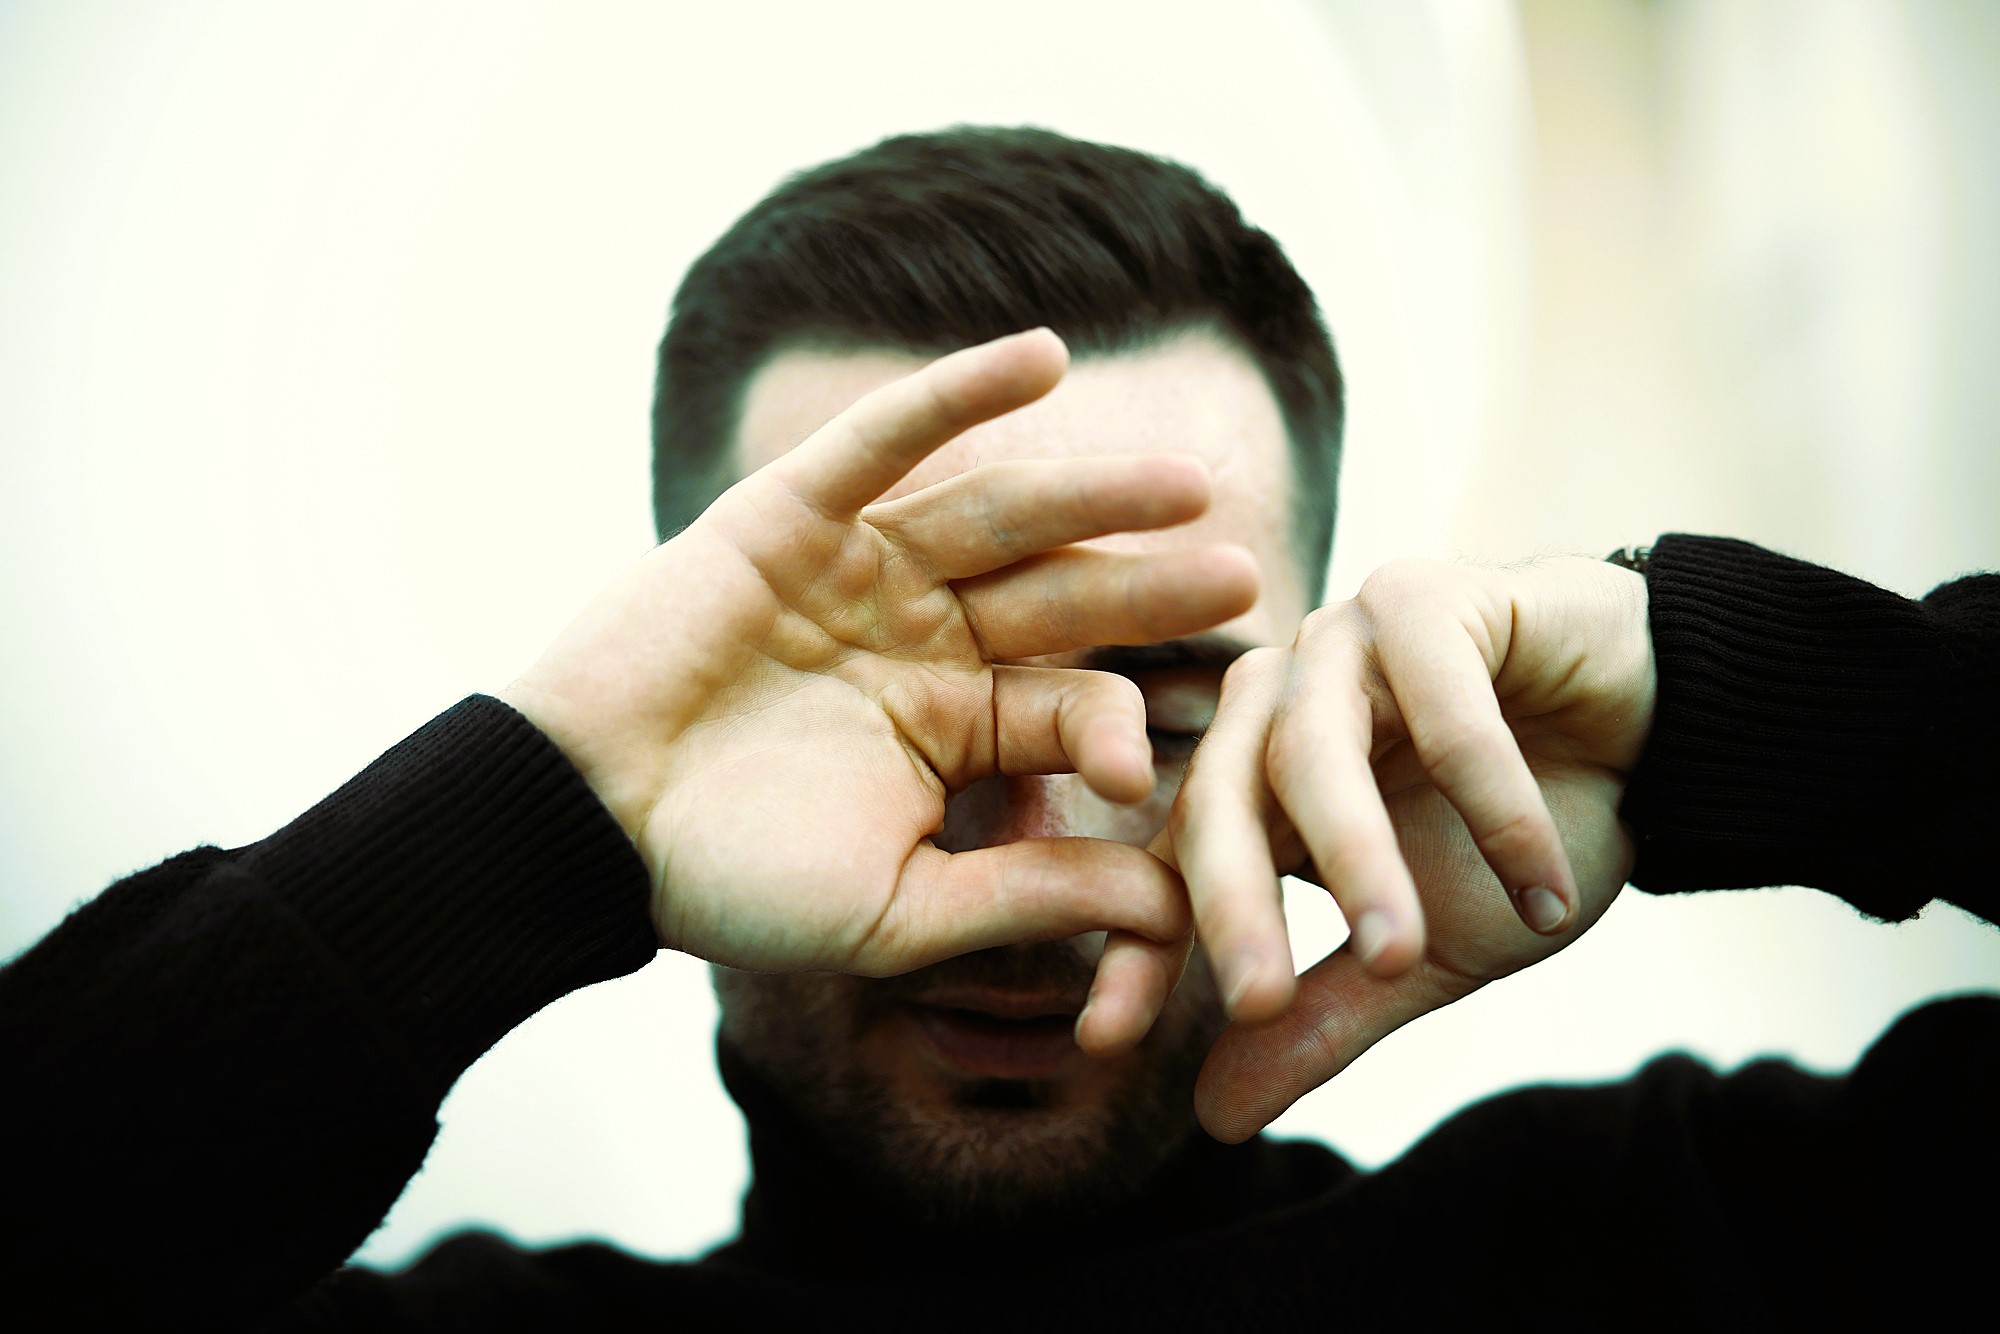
<box><xmin>736</xmin><ymin>330</ymin><xmax>1306</xmax><ymax>642</ymax></box>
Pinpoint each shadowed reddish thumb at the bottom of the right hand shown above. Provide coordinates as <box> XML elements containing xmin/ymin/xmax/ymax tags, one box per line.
<box><xmin>1194</xmin><ymin>948</ymin><xmax>1462</xmax><ymax>1144</ymax></box>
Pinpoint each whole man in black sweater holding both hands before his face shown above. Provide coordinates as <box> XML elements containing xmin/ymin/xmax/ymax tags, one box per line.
<box><xmin>0</xmin><ymin>132</ymin><xmax>2000</xmax><ymax>1328</ymax></box>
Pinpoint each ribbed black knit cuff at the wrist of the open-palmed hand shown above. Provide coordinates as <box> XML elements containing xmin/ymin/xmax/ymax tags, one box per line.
<box><xmin>240</xmin><ymin>696</ymin><xmax>656</xmax><ymax>1094</ymax></box>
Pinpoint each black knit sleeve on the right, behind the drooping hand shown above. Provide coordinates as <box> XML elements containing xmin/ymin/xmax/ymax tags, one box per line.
<box><xmin>1620</xmin><ymin>534</ymin><xmax>2000</xmax><ymax>920</ymax></box>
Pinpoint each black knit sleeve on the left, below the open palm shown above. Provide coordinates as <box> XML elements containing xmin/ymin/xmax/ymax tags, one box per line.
<box><xmin>0</xmin><ymin>696</ymin><xmax>654</xmax><ymax>1328</ymax></box>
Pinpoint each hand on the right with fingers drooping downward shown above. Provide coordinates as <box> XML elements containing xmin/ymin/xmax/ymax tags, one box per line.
<box><xmin>1078</xmin><ymin>558</ymin><xmax>1654</xmax><ymax>1142</ymax></box>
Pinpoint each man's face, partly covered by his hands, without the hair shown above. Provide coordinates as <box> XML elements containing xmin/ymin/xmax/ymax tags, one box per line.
<box><xmin>716</xmin><ymin>332</ymin><xmax>1308</xmax><ymax>1226</ymax></box>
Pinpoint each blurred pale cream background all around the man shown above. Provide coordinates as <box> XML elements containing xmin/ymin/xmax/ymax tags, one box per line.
<box><xmin>0</xmin><ymin>0</ymin><xmax>2000</xmax><ymax>1264</ymax></box>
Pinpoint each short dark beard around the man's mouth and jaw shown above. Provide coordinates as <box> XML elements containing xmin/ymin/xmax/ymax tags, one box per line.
<box><xmin>716</xmin><ymin>944</ymin><xmax>1222</xmax><ymax>1234</ymax></box>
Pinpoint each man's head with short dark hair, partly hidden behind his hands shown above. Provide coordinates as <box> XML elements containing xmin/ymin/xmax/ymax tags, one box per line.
<box><xmin>654</xmin><ymin>130</ymin><xmax>1342</xmax><ymax>1224</ymax></box>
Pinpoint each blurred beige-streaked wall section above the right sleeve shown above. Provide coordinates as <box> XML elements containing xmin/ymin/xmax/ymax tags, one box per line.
<box><xmin>1454</xmin><ymin>0</ymin><xmax>2000</xmax><ymax>592</ymax></box>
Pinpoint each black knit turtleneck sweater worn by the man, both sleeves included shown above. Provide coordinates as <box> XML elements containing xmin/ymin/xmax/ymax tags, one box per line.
<box><xmin>0</xmin><ymin>538</ymin><xmax>2000</xmax><ymax>1330</ymax></box>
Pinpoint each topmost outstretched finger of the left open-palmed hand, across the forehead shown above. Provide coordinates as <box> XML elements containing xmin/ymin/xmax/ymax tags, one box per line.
<box><xmin>768</xmin><ymin>328</ymin><xmax>1070</xmax><ymax>518</ymax></box>
